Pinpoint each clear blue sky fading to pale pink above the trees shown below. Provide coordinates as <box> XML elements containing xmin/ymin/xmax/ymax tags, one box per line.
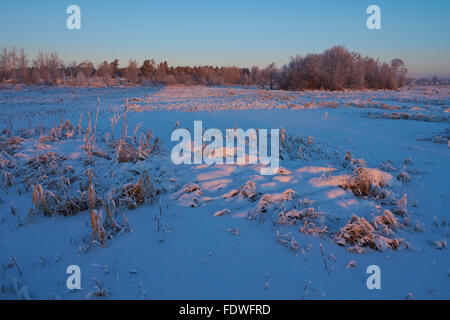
<box><xmin>0</xmin><ymin>0</ymin><xmax>450</xmax><ymax>76</ymax></box>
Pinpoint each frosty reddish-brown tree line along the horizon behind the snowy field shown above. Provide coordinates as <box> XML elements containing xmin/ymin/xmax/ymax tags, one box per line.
<box><xmin>0</xmin><ymin>46</ymin><xmax>408</xmax><ymax>90</ymax></box>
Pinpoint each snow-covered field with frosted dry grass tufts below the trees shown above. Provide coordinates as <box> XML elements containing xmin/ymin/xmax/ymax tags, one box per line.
<box><xmin>0</xmin><ymin>86</ymin><xmax>450</xmax><ymax>299</ymax></box>
